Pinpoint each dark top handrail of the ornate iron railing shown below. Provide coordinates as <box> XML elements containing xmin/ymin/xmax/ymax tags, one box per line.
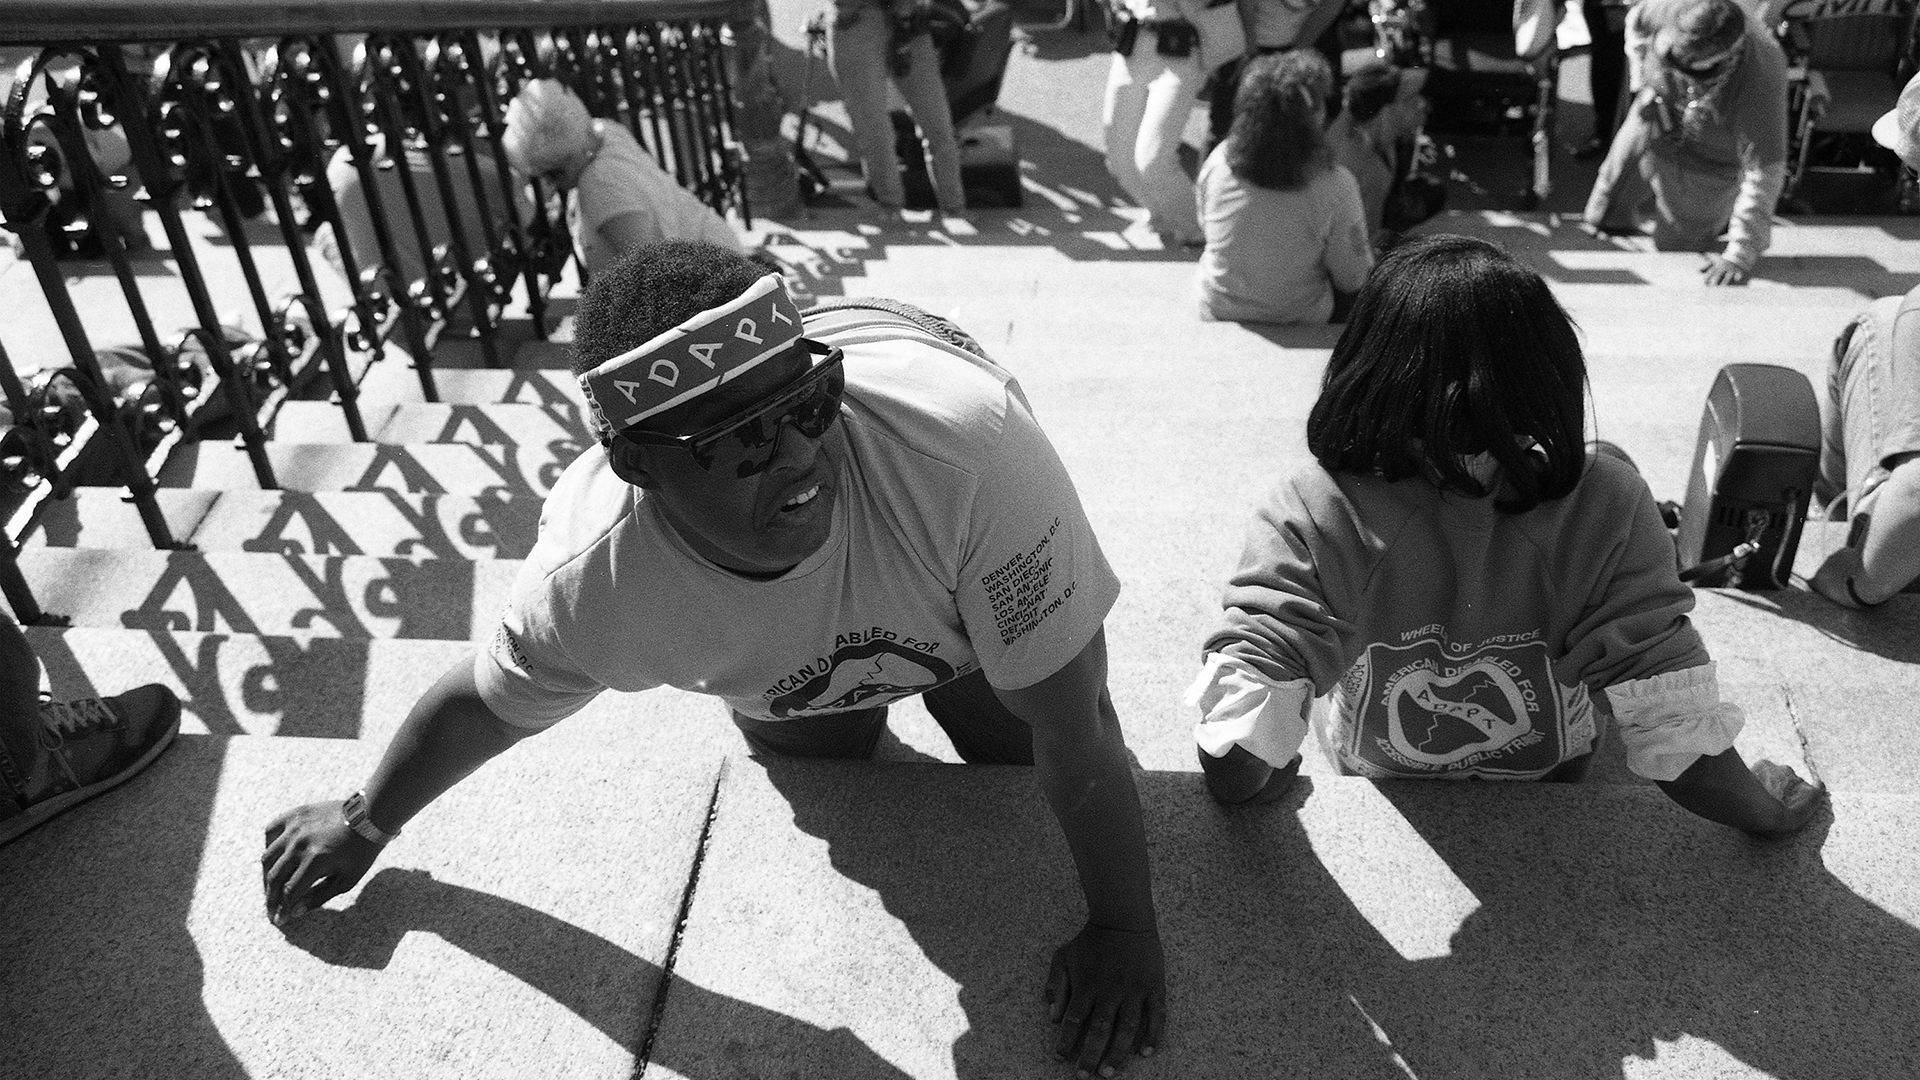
<box><xmin>0</xmin><ymin>0</ymin><xmax>753</xmax><ymax>44</ymax></box>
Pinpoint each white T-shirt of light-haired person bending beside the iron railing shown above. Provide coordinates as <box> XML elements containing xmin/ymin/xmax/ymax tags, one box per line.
<box><xmin>566</xmin><ymin>119</ymin><xmax>745</xmax><ymax>273</ymax></box>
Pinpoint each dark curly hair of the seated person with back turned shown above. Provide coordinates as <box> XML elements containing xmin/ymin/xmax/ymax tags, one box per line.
<box><xmin>1227</xmin><ymin>48</ymin><xmax>1332</xmax><ymax>192</ymax></box>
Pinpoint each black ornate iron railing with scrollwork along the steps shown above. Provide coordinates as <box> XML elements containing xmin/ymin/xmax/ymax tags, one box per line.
<box><xmin>0</xmin><ymin>0</ymin><xmax>751</xmax><ymax>623</ymax></box>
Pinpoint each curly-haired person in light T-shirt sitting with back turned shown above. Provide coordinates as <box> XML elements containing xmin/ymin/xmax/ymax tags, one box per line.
<box><xmin>1194</xmin><ymin>50</ymin><xmax>1373</xmax><ymax>323</ymax></box>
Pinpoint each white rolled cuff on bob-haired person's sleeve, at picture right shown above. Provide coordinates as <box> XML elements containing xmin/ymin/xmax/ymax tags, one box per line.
<box><xmin>1607</xmin><ymin>663</ymin><xmax>1747</xmax><ymax>780</ymax></box>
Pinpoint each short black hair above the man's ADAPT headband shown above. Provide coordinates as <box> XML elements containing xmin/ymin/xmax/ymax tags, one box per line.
<box><xmin>572</xmin><ymin>240</ymin><xmax>768</xmax><ymax>375</ymax></box>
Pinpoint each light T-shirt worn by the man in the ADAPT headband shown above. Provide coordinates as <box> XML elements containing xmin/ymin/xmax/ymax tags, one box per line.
<box><xmin>474</xmin><ymin>319</ymin><xmax>1119</xmax><ymax>726</ymax></box>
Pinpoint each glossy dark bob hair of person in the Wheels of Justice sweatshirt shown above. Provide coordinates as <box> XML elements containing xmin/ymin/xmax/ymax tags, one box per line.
<box><xmin>1308</xmin><ymin>236</ymin><xmax>1586</xmax><ymax>513</ymax></box>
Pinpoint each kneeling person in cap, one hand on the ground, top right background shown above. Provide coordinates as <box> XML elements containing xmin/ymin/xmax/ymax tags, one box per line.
<box><xmin>1586</xmin><ymin>0</ymin><xmax>1788</xmax><ymax>284</ymax></box>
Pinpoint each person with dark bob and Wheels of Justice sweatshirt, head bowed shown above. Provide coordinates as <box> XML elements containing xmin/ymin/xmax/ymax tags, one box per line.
<box><xmin>1187</xmin><ymin>236</ymin><xmax>1824</xmax><ymax>836</ymax></box>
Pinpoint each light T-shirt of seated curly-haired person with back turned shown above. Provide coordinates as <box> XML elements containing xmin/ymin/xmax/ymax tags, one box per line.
<box><xmin>1194</xmin><ymin>140</ymin><xmax>1373</xmax><ymax>323</ymax></box>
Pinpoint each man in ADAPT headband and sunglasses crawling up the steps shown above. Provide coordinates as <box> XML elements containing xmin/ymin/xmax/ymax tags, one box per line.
<box><xmin>263</xmin><ymin>242</ymin><xmax>1165</xmax><ymax>1076</ymax></box>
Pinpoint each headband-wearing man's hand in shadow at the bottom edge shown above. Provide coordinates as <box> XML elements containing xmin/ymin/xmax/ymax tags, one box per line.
<box><xmin>1046</xmin><ymin>922</ymin><xmax>1167</xmax><ymax>1076</ymax></box>
